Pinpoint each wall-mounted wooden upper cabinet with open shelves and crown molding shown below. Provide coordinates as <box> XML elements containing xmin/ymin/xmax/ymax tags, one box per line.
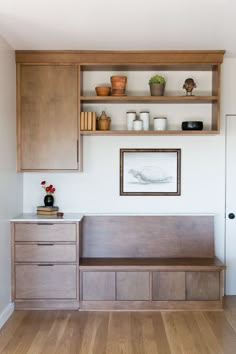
<box><xmin>16</xmin><ymin>50</ymin><xmax>224</xmax><ymax>171</ymax></box>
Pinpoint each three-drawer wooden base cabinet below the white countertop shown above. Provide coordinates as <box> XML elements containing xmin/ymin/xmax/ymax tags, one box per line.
<box><xmin>12</xmin><ymin>221</ymin><xmax>79</xmax><ymax>308</ymax></box>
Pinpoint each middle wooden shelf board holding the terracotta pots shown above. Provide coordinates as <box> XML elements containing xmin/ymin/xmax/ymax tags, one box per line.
<box><xmin>80</xmin><ymin>96</ymin><xmax>218</xmax><ymax>103</ymax></box>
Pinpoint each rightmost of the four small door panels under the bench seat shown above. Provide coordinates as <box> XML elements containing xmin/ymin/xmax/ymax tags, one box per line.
<box><xmin>186</xmin><ymin>272</ymin><xmax>220</xmax><ymax>300</ymax></box>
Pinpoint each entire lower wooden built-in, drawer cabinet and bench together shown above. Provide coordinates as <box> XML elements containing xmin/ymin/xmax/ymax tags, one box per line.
<box><xmin>12</xmin><ymin>215</ymin><xmax>225</xmax><ymax>310</ymax></box>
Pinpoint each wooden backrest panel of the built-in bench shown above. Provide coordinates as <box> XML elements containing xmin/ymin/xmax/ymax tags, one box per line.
<box><xmin>82</xmin><ymin>215</ymin><xmax>214</xmax><ymax>258</ymax></box>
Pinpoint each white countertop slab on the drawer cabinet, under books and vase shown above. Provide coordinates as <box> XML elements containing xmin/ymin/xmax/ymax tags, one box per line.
<box><xmin>11</xmin><ymin>213</ymin><xmax>84</xmax><ymax>222</ymax></box>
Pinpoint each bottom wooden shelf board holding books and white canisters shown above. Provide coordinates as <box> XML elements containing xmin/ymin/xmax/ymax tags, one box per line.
<box><xmin>80</xmin><ymin>130</ymin><xmax>219</xmax><ymax>136</ymax></box>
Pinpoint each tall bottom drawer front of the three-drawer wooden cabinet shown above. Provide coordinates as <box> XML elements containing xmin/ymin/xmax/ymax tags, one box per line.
<box><xmin>15</xmin><ymin>264</ymin><xmax>77</xmax><ymax>300</ymax></box>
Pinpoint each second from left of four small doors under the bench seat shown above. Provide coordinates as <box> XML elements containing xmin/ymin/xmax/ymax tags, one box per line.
<box><xmin>116</xmin><ymin>272</ymin><xmax>150</xmax><ymax>301</ymax></box>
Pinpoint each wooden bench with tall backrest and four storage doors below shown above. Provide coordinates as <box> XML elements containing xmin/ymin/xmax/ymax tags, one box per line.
<box><xmin>79</xmin><ymin>215</ymin><xmax>225</xmax><ymax>310</ymax></box>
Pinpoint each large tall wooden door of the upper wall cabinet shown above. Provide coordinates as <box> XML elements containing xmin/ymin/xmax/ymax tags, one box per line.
<box><xmin>17</xmin><ymin>65</ymin><xmax>78</xmax><ymax>171</ymax></box>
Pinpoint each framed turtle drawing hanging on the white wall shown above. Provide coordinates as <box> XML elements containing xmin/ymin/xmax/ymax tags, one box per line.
<box><xmin>120</xmin><ymin>149</ymin><xmax>181</xmax><ymax>196</ymax></box>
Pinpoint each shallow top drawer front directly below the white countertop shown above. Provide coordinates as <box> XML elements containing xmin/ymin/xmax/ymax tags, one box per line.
<box><xmin>15</xmin><ymin>223</ymin><xmax>76</xmax><ymax>242</ymax></box>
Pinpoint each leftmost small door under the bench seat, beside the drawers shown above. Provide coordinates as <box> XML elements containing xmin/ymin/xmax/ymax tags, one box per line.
<box><xmin>82</xmin><ymin>272</ymin><xmax>115</xmax><ymax>301</ymax></box>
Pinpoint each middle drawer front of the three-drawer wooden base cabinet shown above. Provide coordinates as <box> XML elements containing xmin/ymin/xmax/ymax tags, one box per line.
<box><xmin>15</xmin><ymin>243</ymin><xmax>76</xmax><ymax>262</ymax></box>
